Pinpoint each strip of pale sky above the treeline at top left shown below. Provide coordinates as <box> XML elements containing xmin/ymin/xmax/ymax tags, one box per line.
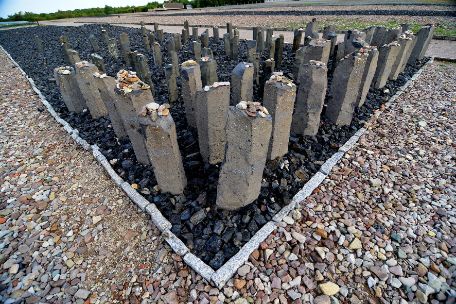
<box><xmin>0</xmin><ymin>0</ymin><xmax>159</xmax><ymax>18</ymax></box>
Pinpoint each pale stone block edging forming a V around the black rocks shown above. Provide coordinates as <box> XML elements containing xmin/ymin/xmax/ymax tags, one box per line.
<box><xmin>0</xmin><ymin>45</ymin><xmax>434</xmax><ymax>288</ymax></box>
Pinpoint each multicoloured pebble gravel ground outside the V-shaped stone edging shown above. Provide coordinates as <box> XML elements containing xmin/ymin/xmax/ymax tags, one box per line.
<box><xmin>0</xmin><ymin>54</ymin><xmax>456</xmax><ymax>304</ymax></box>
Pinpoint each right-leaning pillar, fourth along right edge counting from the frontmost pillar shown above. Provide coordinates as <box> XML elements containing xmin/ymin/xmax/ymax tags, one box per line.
<box><xmin>326</xmin><ymin>53</ymin><xmax>366</xmax><ymax>126</ymax></box>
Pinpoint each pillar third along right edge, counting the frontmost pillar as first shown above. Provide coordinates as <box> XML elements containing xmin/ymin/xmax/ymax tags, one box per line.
<box><xmin>291</xmin><ymin>60</ymin><xmax>328</xmax><ymax>136</ymax></box>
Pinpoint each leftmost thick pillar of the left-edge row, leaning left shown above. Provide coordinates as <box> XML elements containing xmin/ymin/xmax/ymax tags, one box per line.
<box><xmin>54</xmin><ymin>66</ymin><xmax>87</xmax><ymax>113</ymax></box>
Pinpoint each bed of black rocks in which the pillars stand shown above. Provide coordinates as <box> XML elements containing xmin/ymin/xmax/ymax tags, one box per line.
<box><xmin>0</xmin><ymin>25</ymin><xmax>427</xmax><ymax>269</ymax></box>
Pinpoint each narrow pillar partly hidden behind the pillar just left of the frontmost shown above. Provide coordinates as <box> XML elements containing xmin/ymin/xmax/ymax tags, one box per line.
<box><xmin>181</xmin><ymin>60</ymin><xmax>203</xmax><ymax>128</ymax></box>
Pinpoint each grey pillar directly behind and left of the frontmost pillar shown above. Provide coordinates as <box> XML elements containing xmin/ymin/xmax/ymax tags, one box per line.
<box><xmin>196</xmin><ymin>82</ymin><xmax>230</xmax><ymax>164</ymax></box>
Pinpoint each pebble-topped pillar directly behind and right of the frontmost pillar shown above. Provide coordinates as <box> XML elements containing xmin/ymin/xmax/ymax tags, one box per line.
<box><xmin>263</xmin><ymin>73</ymin><xmax>296</xmax><ymax>159</ymax></box>
